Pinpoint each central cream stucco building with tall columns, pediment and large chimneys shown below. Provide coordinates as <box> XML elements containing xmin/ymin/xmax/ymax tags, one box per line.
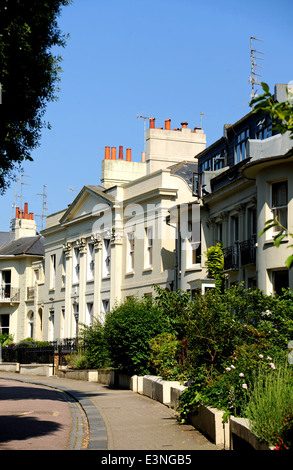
<box><xmin>42</xmin><ymin>120</ymin><xmax>205</xmax><ymax>341</ymax></box>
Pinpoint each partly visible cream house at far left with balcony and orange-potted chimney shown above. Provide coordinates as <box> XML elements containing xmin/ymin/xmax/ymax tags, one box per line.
<box><xmin>0</xmin><ymin>204</ymin><xmax>44</xmax><ymax>342</ymax></box>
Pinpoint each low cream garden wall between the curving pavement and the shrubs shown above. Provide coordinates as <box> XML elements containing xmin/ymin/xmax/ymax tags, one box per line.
<box><xmin>0</xmin><ymin>363</ymin><xmax>271</xmax><ymax>450</ymax></box>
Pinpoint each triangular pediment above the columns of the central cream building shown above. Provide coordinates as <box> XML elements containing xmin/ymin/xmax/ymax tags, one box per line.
<box><xmin>60</xmin><ymin>186</ymin><xmax>113</xmax><ymax>225</ymax></box>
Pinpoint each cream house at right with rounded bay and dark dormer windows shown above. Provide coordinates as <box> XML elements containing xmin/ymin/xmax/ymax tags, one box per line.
<box><xmin>198</xmin><ymin>92</ymin><xmax>293</xmax><ymax>294</ymax></box>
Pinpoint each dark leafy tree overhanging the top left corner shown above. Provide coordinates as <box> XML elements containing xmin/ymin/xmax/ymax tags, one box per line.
<box><xmin>0</xmin><ymin>0</ymin><xmax>71</xmax><ymax>194</ymax></box>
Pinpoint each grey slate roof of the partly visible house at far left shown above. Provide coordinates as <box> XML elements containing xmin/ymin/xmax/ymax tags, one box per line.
<box><xmin>0</xmin><ymin>235</ymin><xmax>45</xmax><ymax>256</ymax></box>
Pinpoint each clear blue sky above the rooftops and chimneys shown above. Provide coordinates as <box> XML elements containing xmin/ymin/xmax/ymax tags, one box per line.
<box><xmin>0</xmin><ymin>0</ymin><xmax>293</xmax><ymax>231</ymax></box>
